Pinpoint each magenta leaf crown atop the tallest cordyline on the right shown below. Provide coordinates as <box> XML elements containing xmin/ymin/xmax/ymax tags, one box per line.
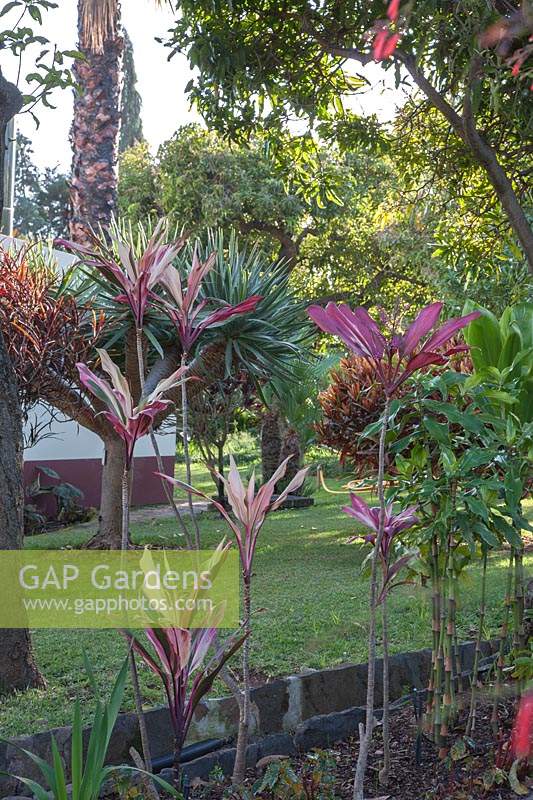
<box><xmin>308</xmin><ymin>303</ymin><xmax>479</xmax><ymax>397</ymax></box>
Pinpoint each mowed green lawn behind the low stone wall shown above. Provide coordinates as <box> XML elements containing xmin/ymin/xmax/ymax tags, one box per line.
<box><xmin>0</xmin><ymin>467</ymin><xmax>533</xmax><ymax>736</ymax></box>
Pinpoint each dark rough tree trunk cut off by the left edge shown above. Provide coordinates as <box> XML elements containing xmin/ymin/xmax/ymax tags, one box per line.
<box><xmin>0</xmin><ymin>333</ymin><xmax>45</xmax><ymax>693</ymax></box>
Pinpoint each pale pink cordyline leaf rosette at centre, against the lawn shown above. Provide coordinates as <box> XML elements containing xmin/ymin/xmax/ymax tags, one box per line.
<box><xmin>157</xmin><ymin>456</ymin><xmax>309</xmax><ymax>577</ymax></box>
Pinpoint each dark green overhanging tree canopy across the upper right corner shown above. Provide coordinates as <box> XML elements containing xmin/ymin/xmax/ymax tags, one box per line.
<box><xmin>167</xmin><ymin>0</ymin><xmax>533</xmax><ymax>271</ymax></box>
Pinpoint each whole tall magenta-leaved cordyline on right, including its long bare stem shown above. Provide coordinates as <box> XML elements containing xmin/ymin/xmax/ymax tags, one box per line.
<box><xmin>308</xmin><ymin>303</ymin><xmax>479</xmax><ymax>800</ymax></box>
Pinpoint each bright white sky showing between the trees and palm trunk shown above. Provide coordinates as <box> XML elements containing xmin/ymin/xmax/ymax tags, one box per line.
<box><xmin>2</xmin><ymin>0</ymin><xmax>405</xmax><ymax>172</ymax></box>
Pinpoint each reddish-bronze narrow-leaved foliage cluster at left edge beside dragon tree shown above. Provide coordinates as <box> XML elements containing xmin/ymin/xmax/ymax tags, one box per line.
<box><xmin>0</xmin><ymin>248</ymin><xmax>103</xmax><ymax>411</ymax></box>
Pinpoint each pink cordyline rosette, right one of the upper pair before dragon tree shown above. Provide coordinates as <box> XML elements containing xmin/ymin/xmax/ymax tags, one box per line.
<box><xmin>161</xmin><ymin>250</ymin><xmax>262</xmax><ymax>353</ymax></box>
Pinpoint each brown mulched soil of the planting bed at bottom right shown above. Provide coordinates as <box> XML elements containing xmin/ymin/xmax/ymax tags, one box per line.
<box><xmin>191</xmin><ymin>700</ymin><xmax>533</xmax><ymax>800</ymax></box>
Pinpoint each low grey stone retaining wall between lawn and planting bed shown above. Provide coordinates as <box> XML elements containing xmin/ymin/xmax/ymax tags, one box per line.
<box><xmin>0</xmin><ymin>642</ymin><xmax>494</xmax><ymax>798</ymax></box>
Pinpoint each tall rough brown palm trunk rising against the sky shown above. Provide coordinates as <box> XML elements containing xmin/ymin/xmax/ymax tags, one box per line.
<box><xmin>70</xmin><ymin>0</ymin><xmax>124</xmax><ymax>243</ymax></box>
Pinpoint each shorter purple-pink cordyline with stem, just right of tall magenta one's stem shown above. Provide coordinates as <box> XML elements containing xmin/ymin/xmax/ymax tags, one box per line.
<box><xmin>342</xmin><ymin>494</ymin><xmax>419</xmax><ymax>785</ymax></box>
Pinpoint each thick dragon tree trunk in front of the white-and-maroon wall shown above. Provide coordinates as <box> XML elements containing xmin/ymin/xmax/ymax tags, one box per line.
<box><xmin>87</xmin><ymin>436</ymin><xmax>125</xmax><ymax>550</ymax></box>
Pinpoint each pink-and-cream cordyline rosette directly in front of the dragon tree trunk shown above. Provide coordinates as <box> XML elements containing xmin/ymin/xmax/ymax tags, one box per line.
<box><xmin>76</xmin><ymin>350</ymin><xmax>186</xmax><ymax>468</ymax></box>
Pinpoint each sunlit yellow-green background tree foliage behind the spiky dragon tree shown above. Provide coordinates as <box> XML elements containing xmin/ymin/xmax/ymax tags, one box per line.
<box><xmin>119</xmin><ymin>126</ymin><xmax>431</xmax><ymax>308</ymax></box>
